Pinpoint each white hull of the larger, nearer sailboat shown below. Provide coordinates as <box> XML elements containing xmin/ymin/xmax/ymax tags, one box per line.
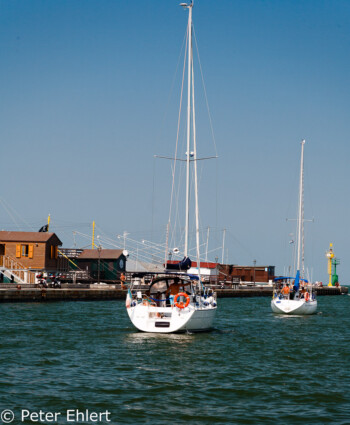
<box><xmin>127</xmin><ymin>303</ymin><xmax>216</xmax><ymax>333</ymax></box>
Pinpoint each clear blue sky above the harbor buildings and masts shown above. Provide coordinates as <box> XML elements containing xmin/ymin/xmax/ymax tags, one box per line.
<box><xmin>0</xmin><ymin>0</ymin><xmax>350</xmax><ymax>283</ymax></box>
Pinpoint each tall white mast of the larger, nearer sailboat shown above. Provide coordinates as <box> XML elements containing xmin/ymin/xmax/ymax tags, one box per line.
<box><xmin>181</xmin><ymin>3</ymin><xmax>192</xmax><ymax>257</ymax></box>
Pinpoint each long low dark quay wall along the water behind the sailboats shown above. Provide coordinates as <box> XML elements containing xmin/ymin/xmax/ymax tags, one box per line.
<box><xmin>0</xmin><ymin>285</ymin><xmax>348</xmax><ymax>303</ymax></box>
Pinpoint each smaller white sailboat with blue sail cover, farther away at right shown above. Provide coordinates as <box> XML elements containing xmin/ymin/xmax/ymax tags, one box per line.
<box><xmin>271</xmin><ymin>140</ymin><xmax>317</xmax><ymax>315</ymax></box>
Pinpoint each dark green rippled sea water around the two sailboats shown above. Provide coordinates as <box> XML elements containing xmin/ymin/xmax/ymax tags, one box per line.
<box><xmin>0</xmin><ymin>296</ymin><xmax>350</xmax><ymax>425</ymax></box>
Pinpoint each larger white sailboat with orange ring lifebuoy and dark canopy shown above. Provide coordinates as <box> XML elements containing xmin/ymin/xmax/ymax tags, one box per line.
<box><xmin>126</xmin><ymin>2</ymin><xmax>217</xmax><ymax>333</ymax></box>
